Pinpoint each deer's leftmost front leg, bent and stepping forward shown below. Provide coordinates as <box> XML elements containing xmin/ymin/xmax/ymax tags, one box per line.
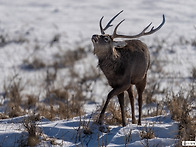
<box><xmin>98</xmin><ymin>85</ymin><xmax>129</xmax><ymax>125</ymax></box>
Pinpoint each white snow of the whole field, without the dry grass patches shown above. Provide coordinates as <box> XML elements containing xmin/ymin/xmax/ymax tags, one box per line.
<box><xmin>0</xmin><ymin>0</ymin><xmax>196</xmax><ymax>147</ymax></box>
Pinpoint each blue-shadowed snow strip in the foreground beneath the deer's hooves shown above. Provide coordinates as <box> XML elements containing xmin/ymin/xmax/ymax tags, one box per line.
<box><xmin>0</xmin><ymin>115</ymin><xmax>178</xmax><ymax>146</ymax></box>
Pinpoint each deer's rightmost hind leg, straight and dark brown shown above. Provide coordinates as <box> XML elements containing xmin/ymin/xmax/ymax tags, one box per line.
<box><xmin>136</xmin><ymin>75</ymin><xmax>146</xmax><ymax>125</ymax></box>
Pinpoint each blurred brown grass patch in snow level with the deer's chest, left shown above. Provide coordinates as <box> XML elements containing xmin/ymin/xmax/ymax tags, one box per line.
<box><xmin>21</xmin><ymin>38</ymin><xmax>89</xmax><ymax>70</ymax></box>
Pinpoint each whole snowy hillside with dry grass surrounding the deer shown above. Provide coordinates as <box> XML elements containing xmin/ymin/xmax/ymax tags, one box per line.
<box><xmin>0</xmin><ymin>0</ymin><xmax>196</xmax><ymax>147</ymax></box>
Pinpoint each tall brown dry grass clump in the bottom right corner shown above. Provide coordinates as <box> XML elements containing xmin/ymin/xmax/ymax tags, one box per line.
<box><xmin>167</xmin><ymin>87</ymin><xmax>196</xmax><ymax>144</ymax></box>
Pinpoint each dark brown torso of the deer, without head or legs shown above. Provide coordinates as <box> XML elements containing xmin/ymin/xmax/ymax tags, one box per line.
<box><xmin>98</xmin><ymin>40</ymin><xmax>150</xmax><ymax>88</ymax></box>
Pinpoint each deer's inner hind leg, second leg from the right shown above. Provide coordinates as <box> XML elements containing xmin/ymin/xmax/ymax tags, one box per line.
<box><xmin>127</xmin><ymin>85</ymin><xmax>136</xmax><ymax>124</ymax></box>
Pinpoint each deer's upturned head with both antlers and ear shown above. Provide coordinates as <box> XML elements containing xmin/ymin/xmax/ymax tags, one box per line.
<box><xmin>92</xmin><ymin>10</ymin><xmax>165</xmax><ymax>57</ymax></box>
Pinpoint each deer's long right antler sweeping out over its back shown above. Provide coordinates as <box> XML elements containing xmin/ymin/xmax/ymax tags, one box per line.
<box><xmin>112</xmin><ymin>14</ymin><xmax>165</xmax><ymax>38</ymax></box>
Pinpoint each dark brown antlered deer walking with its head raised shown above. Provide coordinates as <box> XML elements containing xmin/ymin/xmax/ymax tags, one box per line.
<box><xmin>91</xmin><ymin>10</ymin><xmax>165</xmax><ymax>127</ymax></box>
